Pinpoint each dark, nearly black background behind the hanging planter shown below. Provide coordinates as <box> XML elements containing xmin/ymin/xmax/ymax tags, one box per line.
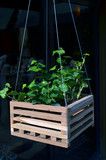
<box><xmin>0</xmin><ymin>0</ymin><xmax>101</xmax><ymax>160</ymax></box>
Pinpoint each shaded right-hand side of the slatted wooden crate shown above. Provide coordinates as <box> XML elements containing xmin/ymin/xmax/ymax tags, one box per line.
<box><xmin>68</xmin><ymin>95</ymin><xmax>94</xmax><ymax>142</ymax></box>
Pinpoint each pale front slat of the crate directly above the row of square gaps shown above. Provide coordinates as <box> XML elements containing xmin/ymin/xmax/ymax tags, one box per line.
<box><xmin>11</xmin><ymin>123</ymin><xmax>67</xmax><ymax>139</ymax></box>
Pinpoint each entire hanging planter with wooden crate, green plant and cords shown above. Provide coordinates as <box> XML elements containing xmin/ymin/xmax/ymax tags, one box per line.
<box><xmin>0</xmin><ymin>0</ymin><xmax>94</xmax><ymax>148</ymax></box>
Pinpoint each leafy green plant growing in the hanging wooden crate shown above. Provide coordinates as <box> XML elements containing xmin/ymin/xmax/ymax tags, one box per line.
<box><xmin>0</xmin><ymin>48</ymin><xmax>89</xmax><ymax>104</ymax></box>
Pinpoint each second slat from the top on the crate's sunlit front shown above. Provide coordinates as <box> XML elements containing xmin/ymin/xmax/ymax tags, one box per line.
<box><xmin>12</xmin><ymin>109</ymin><xmax>64</xmax><ymax>122</ymax></box>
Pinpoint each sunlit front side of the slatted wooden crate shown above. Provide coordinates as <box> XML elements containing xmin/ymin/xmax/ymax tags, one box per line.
<box><xmin>10</xmin><ymin>101</ymin><xmax>68</xmax><ymax>148</ymax></box>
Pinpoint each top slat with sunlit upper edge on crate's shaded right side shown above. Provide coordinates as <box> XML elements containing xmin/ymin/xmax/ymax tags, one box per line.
<box><xmin>68</xmin><ymin>95</ymin><xmax>93</xmax><ymax>114</ymax></box>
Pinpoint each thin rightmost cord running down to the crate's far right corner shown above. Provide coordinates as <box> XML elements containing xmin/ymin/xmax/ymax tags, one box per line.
<box><xmin>68</xmin><ymin>0</ymin><xmax>92</xmax><ymax>94</ymax></box>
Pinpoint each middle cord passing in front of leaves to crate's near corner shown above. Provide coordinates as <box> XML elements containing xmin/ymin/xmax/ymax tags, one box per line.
<box><xmin>53</xmin><ymin>0</ymin><xmax>67</xmax><ymax>106</ymax></box>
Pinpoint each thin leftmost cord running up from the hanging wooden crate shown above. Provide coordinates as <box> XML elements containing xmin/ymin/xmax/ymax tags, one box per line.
<box><xmin>15</xmin><ymin>0</ymin><xmax>31</xmax><ymax>90</ymax></box>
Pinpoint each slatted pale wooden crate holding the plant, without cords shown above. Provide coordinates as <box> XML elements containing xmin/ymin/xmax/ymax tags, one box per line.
<box><xmin>10</xmin><ymin>95</ymin><xmax>94</xmax><ymax>148</ymax></box>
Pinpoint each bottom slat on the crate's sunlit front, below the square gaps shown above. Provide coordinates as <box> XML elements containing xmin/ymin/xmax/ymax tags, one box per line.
<box><xmin>12</xmin><ymin>132</ymin><xmax>68</xmax><ymax>148</ymax></box>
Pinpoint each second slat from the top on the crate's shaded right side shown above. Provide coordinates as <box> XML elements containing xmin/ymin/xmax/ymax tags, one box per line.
<box><xmin>70</xmin><ymin>107</ymin><xmax>94</xmax><ymax>124</ymax></box>
